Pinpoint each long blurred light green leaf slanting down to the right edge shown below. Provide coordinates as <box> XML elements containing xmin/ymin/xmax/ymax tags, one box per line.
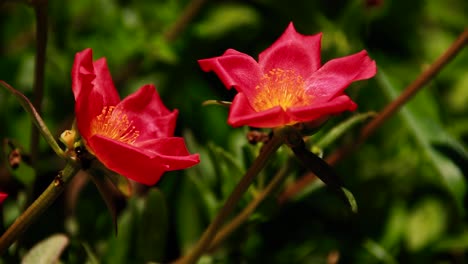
<box><xmin>376</xmin><ymin>71</ymin><xmax>466</xmax><ymax>212</ymax></box>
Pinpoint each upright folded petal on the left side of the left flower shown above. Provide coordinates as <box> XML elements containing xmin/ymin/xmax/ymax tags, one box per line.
<box><xmin>72</xmin><ymin>49</ymin><xmax>120</xmax><ymax>140</ymax></box>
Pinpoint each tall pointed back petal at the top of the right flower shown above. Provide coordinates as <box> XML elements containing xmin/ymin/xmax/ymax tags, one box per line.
<box><xmin>259</xmin><ymin>23</ymin><xmax>322</xmax><ymax>79</ymax></box>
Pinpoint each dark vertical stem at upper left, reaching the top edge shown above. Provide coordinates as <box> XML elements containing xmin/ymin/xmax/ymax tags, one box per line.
<box><xmin>31</xmin><ymin>0</ymin><xmax>47</xmax><ymax>164</ymax></box>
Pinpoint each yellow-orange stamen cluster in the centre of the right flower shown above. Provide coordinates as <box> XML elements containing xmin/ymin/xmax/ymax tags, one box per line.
<box><xmin>253</xmin><ymin>69</ymin><xmax>312</xmax><ymax>111</ymax></box>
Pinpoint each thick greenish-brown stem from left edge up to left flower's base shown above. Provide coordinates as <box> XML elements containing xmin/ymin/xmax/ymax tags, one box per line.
<box><xmin>0</xmin><ymin>160</ymin><xmax>80</xmax><ymax>255</ymax></box>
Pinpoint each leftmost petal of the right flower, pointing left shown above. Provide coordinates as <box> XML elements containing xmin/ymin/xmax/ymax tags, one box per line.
<box><xmin>198</xmin><ymin>49</ymin><xmax>263</xmax><ymax>96</ymax></box>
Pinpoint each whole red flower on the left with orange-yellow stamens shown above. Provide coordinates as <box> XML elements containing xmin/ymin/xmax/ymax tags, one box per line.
<box><xmin>72</xmin><ymin>49</ymin><xmax>200</xmax><ymax>185</ymax></box>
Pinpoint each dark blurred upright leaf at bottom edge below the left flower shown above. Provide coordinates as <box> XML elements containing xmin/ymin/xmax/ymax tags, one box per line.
<box><xmin>136</xmin><ymin>188</ymin><xmax>169</xmax><ymax>263</ymax></box>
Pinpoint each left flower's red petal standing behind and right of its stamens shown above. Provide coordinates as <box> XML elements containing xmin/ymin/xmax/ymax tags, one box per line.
<box><xmin>117</xmin><ymin>85</ymin><xmax>178</xmax><ymax>142</ymax></box>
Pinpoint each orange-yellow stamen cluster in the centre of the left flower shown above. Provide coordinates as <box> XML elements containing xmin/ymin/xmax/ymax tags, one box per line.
<box><xmin>91</xmin><ymin>106</ymin><xmax>140</xmax><ymax>144</ymax></box>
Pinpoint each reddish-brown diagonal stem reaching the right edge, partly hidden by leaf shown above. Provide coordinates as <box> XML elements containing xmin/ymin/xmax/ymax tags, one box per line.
<box><xmin>279</xmin><ymin>29</ymin><xmax>468</xmax><ymax>203</ymax></box>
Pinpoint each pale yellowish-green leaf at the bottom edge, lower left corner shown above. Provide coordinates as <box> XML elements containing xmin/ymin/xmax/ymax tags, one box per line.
<box><xmin>21</xmin><ymin>234</ymin><xmax>69</xmax><ymax>264</ymax></box>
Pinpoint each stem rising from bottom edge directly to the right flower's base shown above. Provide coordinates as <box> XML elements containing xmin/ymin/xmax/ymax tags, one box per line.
<box><xmin>175</xmin><ymin>127</ymin><xmax>290</xmax><ymax>264</ymax></box>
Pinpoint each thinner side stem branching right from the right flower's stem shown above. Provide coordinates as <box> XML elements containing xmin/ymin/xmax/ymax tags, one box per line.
<box><xmin>208</xmin><ymin>159</ymin><xmax>292</xmax><ymax>252</ymax></box>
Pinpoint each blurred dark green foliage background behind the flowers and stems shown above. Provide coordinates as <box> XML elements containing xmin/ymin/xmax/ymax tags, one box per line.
<box><xmin>0</xmin><ymin>0</ymin><xmax>468</xmax><ymax>263</ymax></box>
